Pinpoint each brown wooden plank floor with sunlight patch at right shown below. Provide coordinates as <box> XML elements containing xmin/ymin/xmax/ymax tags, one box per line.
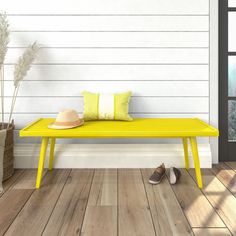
<box><xmin>0</xmin><ymin>163</ymin><xmax>236</xmax><ymax>236</ymax></box>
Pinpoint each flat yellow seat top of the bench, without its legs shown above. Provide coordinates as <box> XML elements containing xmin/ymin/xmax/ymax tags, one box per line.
<box><xmin>20</xmin><ymin>118</ymin><xmax>219</xmax><ymax>138</ymax></box>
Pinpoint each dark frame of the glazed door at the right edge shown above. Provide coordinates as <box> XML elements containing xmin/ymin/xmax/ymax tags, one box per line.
<box><xmin>219</xmin><ymin>0</ymin><xmax>236</xmax><ymax>161</ymax></box>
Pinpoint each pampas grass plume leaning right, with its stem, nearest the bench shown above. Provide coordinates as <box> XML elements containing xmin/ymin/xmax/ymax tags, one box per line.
<box><xmin>8</xmin><ymin>42</ymin><xmax>40</xmax><ymax>126</ymax></box>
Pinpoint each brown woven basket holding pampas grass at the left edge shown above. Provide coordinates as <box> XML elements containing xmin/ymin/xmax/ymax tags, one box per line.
<box><xmin>3</xmin><ymin>123</ymin><xmax>14</xmax><ymax>181</ymax></box>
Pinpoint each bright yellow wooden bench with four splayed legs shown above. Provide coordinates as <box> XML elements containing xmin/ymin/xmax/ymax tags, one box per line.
<box><xmin>20</xmin><ymin>118</ymin><xmax>219</xmax><ymax>188</ymax></box>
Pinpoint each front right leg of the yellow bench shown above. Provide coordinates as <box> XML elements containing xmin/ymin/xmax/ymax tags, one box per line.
<box><xmin>190</xmin><ymin>137</ymin><xmax>202</xmax><ymax>188</ymax></box>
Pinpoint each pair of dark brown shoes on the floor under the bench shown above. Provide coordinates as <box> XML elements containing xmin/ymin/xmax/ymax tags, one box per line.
<box><xmin>149</xmin><ymin>163</ymin><xmax>181</xmax><ymax>184</ymax></box>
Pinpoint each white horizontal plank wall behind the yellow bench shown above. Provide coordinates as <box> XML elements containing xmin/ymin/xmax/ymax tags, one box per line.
<box><xmin>1</xmin><ymin>0</ymin><xmax>209</xmax><ymax>142</ymax></box>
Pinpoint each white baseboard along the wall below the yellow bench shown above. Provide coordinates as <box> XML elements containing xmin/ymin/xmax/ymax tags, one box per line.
<box><xmin>15</xmin><ymin>144</ymin><xmax>212</xmax><ymax>168</ymax></box>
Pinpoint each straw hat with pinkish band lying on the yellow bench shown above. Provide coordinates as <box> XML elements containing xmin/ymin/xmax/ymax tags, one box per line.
<box><xmin>48</xmin><ymin>109</ymin><xmax>84</xmax><ymax>129</ymax></box>
